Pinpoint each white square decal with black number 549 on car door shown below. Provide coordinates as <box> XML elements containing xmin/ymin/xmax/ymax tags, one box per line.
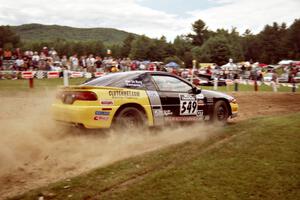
<box><xmin>179</xmin><ymin>94</ymin><xmax>198</xmax><ymax>115</ymax></box>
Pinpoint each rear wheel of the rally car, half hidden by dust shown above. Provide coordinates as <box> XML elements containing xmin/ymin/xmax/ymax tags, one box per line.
<box><xmin>113</xmin><ymin>107</ymin><xmax>146</xmax><ymax>129</ymax></box>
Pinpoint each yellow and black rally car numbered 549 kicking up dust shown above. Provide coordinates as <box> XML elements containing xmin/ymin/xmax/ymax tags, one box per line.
<box><xmin>52</xmin><ymin>71</ymin><xmax>238</xmax><ymax>128</ymax></box>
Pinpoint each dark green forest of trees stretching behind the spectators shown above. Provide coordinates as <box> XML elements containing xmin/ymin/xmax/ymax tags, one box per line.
<box><xmin>0</xmin><ymin>19</ymin><xmax>300</xmax><ymax>67</ymax></box>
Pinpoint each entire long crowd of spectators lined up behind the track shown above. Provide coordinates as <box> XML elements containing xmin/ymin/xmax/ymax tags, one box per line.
<box><xmin>0</xmin><ymin>47</ymin><xmax>300</xmax><ymax>82</ymax></box>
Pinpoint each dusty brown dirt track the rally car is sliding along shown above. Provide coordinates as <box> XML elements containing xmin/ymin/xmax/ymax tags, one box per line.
<box><xmin>0</xmin><ymin>92</ymin><xmax>300</xmax><ymax>199</ymax></box>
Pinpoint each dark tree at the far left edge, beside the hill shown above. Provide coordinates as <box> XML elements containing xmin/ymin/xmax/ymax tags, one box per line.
<box><xmin>0</xmin><ymin>26</ymin><xmax>20</xmax><ymax>48</ymax></box>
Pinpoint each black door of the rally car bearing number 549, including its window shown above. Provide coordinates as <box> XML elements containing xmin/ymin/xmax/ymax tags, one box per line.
<box><xmin>152</xmin><ymin>74</ymin><xmax>203</xmax><ymax>121</ymax></box>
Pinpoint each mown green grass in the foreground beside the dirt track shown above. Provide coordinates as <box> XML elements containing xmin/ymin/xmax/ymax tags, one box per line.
<box><xmin>12</xmin><ymin>113</ymin><xmax>300</xmax><ymax>200</ymax></box>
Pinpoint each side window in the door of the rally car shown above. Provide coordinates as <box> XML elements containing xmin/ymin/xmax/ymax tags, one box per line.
<box><xmin>152</xmin><ymin>75</ymin><xmax>192</xmax><ymax>92</ymax></box>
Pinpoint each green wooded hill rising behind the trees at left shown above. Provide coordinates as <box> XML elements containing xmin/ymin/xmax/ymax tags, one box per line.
<box><xmin>11</xmin><ymin>24</ymin><xmax>137</xmax><ymax>44</ymax></box>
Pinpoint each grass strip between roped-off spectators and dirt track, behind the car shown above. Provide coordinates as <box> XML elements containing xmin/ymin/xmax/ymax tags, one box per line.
<box><xmin>0</xmin><ymin>78</ymin><xmax>300</xmax><ymax>92</ymax></box>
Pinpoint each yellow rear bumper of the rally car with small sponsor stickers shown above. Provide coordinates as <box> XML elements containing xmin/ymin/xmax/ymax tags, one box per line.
<box><xmin>52</xmin><ymin>104</ymin><xmax>115</xmax><ymax>128</ymax></box>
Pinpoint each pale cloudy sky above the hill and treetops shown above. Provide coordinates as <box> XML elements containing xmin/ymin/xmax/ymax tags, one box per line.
<box><xmin>0</xmin><ymin>0</ymin><xmax>300</xmax><ymax>40</ymax></box>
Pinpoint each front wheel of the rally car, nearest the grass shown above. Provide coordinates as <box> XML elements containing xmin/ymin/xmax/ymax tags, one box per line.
<box><xmin>212</xmin><ymin>100</ymin><xmax>229</xmax><ymax>123</ymax></box>
